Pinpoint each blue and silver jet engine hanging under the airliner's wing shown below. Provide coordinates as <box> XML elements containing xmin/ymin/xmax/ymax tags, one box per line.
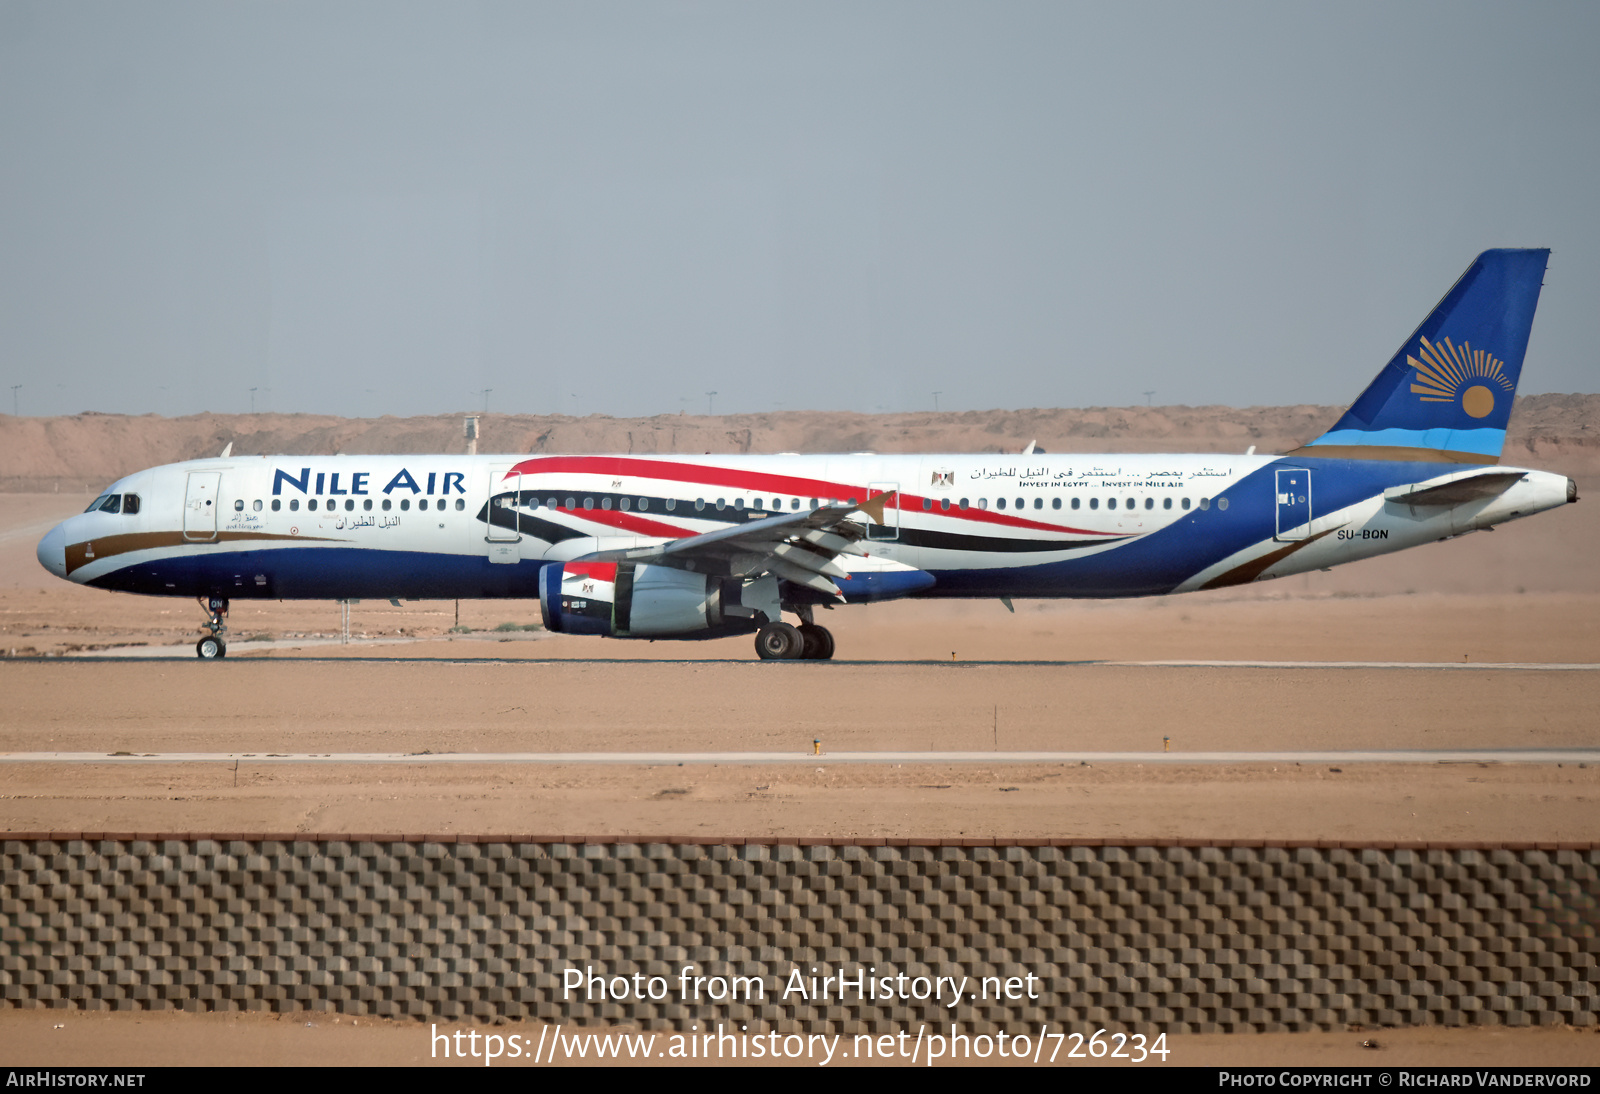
<box><xmin>539</xmin><ymin>561</ymin><xmax>754</xmax><ymax>638</ymax></box>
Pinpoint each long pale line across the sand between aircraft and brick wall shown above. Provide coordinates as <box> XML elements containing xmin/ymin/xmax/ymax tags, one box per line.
<box><xmin>0</xmin><ymin>749</ymin><xmax>1600</xmax><ymax>768</ymax></box>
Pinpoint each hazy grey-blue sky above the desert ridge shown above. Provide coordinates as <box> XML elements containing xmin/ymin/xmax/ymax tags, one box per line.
<box><xmin>0</xmin><ymin>0</ymin><xmax>1600</xmax><ymax>416</ymax></box>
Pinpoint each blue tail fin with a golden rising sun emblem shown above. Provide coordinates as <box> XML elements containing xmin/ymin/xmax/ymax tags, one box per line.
<box><xmin>1298</xmin><ymin>250</ymin><xmax>1550</xmax><ymax>464</ymax></box>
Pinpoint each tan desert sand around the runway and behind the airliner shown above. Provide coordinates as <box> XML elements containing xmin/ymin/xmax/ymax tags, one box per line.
<box><xmin>0</xmin><ymin>406</ymin><xmax>1600</xmax><ymax>1065</ymax></box>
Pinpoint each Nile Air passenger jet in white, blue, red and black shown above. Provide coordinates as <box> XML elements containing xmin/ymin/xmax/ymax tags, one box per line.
<box><xmin>38</xmin><ymin>250</ymin><xmax>1578</xmax><ymax>661</ymax></box>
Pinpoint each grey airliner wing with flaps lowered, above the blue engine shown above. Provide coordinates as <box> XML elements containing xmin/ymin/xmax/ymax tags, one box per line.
<box><xmin>589</xmin><ymin>491</ymin><xmax>894</xmax><ymax>600</ymax></box>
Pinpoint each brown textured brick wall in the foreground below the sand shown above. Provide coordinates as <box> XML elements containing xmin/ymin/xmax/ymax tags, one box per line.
<box><xmin>0</xmin><ymin>833</ymin><xmax>1600</xmax><ymax>1035</ymax></box>
